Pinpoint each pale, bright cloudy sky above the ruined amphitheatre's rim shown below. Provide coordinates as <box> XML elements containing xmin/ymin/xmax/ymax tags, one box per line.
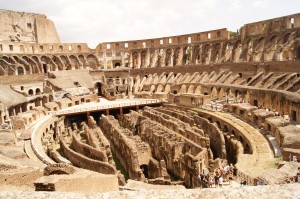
<box><xmin>0</xmin><ymin>0</ymin><xmax>300</xmax><ymax>48</ymax></box>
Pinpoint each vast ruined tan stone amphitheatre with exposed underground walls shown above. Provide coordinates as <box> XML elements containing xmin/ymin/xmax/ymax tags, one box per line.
<box><xmin>0</xmin><ymin>7</ymin><xmax>300</xmax><ymax>198</ymax></box>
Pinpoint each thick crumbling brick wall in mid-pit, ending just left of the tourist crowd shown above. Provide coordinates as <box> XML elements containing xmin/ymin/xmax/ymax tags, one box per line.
<box><xmin>140</xmin><ymin>115</ymin><xmax>208</xmax><ymax>187</ymax></box>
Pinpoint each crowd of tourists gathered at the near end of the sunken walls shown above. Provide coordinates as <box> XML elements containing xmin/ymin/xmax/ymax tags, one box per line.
<box><xmin>199</xmin><ymin>164</ymin><xmax>237</xmax><ymax>188</ymax></box>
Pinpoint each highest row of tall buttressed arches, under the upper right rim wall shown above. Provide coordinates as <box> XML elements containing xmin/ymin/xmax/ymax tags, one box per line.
<box><xmin>115</xmin><ymin>32</ymin><xmax>300</xmax><ymax>68</ymax></box>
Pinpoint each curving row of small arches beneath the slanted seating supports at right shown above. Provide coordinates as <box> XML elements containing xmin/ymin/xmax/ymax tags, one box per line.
<box><xmin>143</xmin><ymin>80</ymin><xmax>300</xmax><ymax>121</ymax></box>
